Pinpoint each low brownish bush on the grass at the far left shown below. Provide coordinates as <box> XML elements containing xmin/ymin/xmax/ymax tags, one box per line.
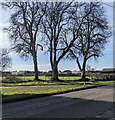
<box><xmin>2</xmin><ymin>76</ymin><xmax>23</xmax><ymax>83</ymax></box>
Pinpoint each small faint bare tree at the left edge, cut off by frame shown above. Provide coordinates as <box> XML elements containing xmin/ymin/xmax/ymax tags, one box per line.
<box><xmin>0</xmin><ymin>48</ymin><xmax>12</xmax><ymax>79</ymax></box>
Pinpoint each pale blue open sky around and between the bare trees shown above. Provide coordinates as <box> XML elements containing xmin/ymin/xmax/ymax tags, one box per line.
<box><xmin>0</xmin><ymin>0</ymin><xmax>113</xmax><ymax>71</ymax></box>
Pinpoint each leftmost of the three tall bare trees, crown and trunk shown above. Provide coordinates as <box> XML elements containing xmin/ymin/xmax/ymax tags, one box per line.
<box><xmin>3</xmin><ymin>2</ymin><xmax>46</xmax><ymax>80</ymax></box>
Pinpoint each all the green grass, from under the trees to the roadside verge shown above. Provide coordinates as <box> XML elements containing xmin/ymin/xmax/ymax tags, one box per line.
<box><xmin>1</xmin><ymin>76</ymin><xmax>115</xmax><ymax>102</ymax></box>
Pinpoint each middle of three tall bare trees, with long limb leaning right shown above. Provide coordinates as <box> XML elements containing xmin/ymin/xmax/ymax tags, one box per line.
<box><xmin>42</xmin><ymin>2</ymin><xmax>94</xmax><ymax>81</ymax></box>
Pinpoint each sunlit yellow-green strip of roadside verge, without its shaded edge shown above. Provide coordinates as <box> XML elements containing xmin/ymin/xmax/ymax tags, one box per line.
<box><xmin>2</xmin><ymin>86</ymin><xmax>79</xmax><ymax>95</ymax></box>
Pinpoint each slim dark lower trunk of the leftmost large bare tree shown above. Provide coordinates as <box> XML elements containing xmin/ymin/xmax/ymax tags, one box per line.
<box><xmin>33</xmin><ymin>53</ymin><xmax>38</xmax><ymax>81</ymax></box>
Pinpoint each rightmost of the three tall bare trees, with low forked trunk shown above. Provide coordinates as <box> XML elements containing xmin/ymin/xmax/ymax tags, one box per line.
<box><xmin>67</xmin><ymin>2</ymin><xmax>111</xmax><ymax>80</ymax></box>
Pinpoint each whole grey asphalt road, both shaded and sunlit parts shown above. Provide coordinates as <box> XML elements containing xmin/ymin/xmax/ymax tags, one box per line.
<box><xmin>2</xmin><ymin>86</ymin><xmax>114</xmax><ymax>118</ymax></box>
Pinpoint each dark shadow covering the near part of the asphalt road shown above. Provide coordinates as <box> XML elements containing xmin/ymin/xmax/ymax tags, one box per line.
<box><xmin>2</xmin><ymin>89</ymin><xmax>115</xmax><ymax>120</ymax></box>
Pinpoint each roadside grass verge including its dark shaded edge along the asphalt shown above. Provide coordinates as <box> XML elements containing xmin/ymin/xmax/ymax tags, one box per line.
<box><xmin>1</xmin><ymin>85</ymin><xmax>94</xmax><ymax>102</ymax></box>
